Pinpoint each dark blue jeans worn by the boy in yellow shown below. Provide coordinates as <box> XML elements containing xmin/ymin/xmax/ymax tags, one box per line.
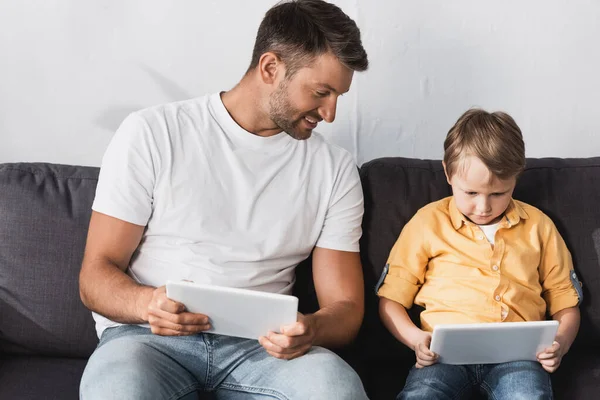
<box><xmin>396</xmin><ymin>361</ymin><xmax>552</xmax><ymax>400</ymax></box>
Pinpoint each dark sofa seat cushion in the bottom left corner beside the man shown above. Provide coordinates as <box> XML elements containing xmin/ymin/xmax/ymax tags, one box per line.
<box><xmin>0</xmin><ymin>356</ymin><xmax>87</xmax><ymax>400</ymax></box>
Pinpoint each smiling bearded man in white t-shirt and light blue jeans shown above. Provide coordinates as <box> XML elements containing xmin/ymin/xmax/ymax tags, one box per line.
<box><xmin>80</xmin><ymin>0</ymin><xmax>368</xmax><ymax>399</ymax></box>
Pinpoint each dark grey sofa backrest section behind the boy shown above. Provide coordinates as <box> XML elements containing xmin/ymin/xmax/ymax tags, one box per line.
<box><xmin>361</xmin><ymin>157</ymin><xmax>600</xmax><ymax>363</ymax></box>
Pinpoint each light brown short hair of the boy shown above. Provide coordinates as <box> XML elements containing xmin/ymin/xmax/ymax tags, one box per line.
<box><xmin>444</xmin><ymin>108</ymin><xmax>525</xmax><ymax>179</ymax></box>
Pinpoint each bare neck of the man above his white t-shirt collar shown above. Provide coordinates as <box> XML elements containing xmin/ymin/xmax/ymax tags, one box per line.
<box><xmin>221</xmin><ymin>77</ymin><xmax>281</xmax><ymax>137</ymax></box>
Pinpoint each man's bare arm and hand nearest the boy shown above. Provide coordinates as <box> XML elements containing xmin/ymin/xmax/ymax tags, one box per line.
<box><xmin>259</xmin><ymin>247</ymin><xmax>364</xmax><ymax>360</ymax></box>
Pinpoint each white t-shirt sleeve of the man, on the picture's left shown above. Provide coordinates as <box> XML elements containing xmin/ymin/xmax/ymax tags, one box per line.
<box><xmin>92</xmin><ymin>113</ymin><xmax>158</xmax><ymax>226</ymax></box>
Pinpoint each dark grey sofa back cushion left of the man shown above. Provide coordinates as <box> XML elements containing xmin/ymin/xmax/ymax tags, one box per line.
<box><xmin>0</xmin><ymin>163</ymin><xmax>98</xmax><ymax>357</ymax></box>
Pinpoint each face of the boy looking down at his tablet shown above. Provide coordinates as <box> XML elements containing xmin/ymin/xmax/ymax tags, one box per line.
<box><xmin>444</xmin><ymin>156</ymin><xmax>517</xmax><ymax>225</ymax></box>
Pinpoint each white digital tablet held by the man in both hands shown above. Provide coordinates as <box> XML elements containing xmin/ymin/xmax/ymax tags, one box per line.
<box><xmin>166</xmin><ymin>281</ymin><xmax>298</xmax><ymax>339</ymax></box>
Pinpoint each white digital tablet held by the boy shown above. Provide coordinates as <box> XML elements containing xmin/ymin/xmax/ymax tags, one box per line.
<box><xmin>429</xmin><ymin>321</ymin><xmax>558</xmax><ymax>365</ymax></box>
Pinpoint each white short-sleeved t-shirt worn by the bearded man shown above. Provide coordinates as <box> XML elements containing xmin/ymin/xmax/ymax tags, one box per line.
<box><xmin>92</xmin><ymin>93</ymin><xmax>363</xmax><ymax>336</ymax></box>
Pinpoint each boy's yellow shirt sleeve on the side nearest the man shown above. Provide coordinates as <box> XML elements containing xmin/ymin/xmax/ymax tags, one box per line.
<box><xmin>376</xmin><ymin>212</ymin><xmax>429</xmax><ymax>309</ymax></box>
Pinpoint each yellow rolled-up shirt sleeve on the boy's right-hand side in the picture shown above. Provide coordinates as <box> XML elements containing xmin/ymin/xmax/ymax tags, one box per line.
<box><xmin>540</xmin><ymin>217</ymin><xmax>582</xmax><ymax>315</ymax></box>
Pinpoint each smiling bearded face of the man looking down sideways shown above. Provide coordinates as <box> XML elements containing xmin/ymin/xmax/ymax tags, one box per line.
<box><xmin>269</xmin><ymin>53</ymin><xmax>354</xmax><ymax>140</ymax></box>
